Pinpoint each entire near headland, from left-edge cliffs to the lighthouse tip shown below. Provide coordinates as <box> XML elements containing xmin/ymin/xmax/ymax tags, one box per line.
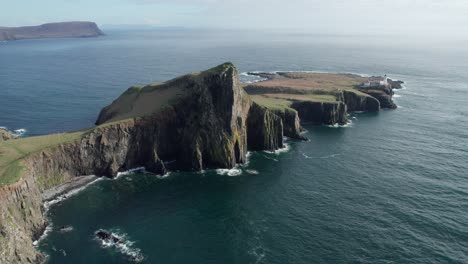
<box><xmin>0</xmin><ymin>63</ymin><xmax>402</xmax><ymax>263</ymax></box>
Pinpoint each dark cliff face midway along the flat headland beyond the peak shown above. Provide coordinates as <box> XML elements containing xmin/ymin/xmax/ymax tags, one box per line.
<box><xmin>291</xmin><ymin>101</ymin><xmax>348</xmax><ymax>125</ymax></box>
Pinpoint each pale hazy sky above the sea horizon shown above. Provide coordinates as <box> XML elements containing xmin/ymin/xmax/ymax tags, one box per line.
<box><xmin>0</xmin><ymin>0</ymin><xmax>468</xmax><ymax>36</ymax></box>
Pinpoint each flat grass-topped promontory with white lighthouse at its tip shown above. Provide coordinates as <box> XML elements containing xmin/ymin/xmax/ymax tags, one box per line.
<box><xmin>244</xmin><ymin>72</ymin><xmax>403</xmax><ymax>125</ymax></box>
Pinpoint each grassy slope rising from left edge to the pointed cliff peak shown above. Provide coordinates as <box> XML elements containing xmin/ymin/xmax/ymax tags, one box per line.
<box><xmin>0</xmin><ymin>63</ymin><xmax>233</xmax><ymax>187</ymax></box>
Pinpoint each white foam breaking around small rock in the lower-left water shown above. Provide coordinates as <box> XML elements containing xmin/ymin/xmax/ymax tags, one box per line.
<box><xmin>95</xmin><ymin>230</ymin><xmax>145</xmax><ymax>262</ymax></box>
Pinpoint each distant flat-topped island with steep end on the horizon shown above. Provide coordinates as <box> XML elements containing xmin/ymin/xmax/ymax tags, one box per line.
<box><xmin>0</xmin><ymin>21</ymin><xmax>104</xmax><ymax>41</ymax></box>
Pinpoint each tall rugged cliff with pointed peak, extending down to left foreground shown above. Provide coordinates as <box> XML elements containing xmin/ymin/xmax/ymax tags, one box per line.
<box><xmin>0</xmin><ymin>63</ymin><xmax>289</xmax><ymax>263</ymax></box>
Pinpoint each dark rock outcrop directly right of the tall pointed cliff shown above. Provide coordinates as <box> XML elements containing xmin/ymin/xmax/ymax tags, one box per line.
<box><xmin>247</xmin><ymin>103</ymin><xmax>283</xmax><ymax>150</ymax></box>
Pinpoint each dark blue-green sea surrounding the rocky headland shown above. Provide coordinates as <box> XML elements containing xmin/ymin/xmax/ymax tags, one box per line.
<box><xmin>0</xmin><ymin>29</ymin><xmax>468</xmax><ymax>264</ymax></box>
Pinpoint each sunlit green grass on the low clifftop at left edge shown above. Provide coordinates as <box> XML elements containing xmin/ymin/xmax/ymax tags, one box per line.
<box><xmin>0</xmin><ymin>131</ymin><xmax>85</xmax><ymax>186</ymax></box>
